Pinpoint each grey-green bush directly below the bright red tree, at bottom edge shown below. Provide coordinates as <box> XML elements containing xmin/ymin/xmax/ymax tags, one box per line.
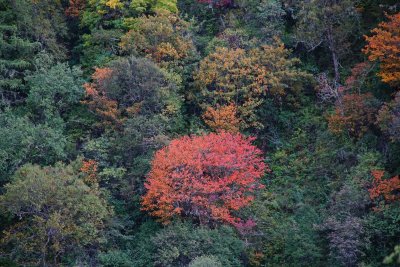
<box><xmin>130</xmin><ymin>223</ymin><xmax>244</xmax><ymax>266</ymax></box>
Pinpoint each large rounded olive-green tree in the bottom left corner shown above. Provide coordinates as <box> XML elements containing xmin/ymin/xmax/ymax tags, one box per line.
<box><xmin>0</xmin><ymin>162</ymin><xmax>110</xmax><ymax>265</ymax></box>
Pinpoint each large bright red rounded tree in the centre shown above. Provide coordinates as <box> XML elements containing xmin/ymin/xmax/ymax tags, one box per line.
<box><xmin>142</xmin><ymin>132</ymin><xmax>269</xmax><ymax>225</ymax></box>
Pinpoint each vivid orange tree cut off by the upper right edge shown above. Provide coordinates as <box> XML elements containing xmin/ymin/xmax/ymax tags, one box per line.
<box><xmin>363</xmin><ymin>13</ymin><xmax>400</xmax><ymax>86</ymax></box>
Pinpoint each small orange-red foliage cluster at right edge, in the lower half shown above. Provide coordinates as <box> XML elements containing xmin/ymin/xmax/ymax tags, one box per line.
<box><xmin>368</xmin><ymin>171</ymin><xmax>400</xmax><ymax>202</ymax></box>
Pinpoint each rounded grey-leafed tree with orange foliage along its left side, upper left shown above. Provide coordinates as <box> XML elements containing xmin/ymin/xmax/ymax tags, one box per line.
<box><xmin>84</xmin><ymin>57</ymin><xmax>180</xmax><ymax>131</ymax></box>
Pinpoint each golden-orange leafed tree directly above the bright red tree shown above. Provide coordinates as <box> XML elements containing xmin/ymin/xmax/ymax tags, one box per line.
<box><xmin>194</xmin><ymin>38</ymin><xmax>307</xmax><ymax>128</ymax></box>
